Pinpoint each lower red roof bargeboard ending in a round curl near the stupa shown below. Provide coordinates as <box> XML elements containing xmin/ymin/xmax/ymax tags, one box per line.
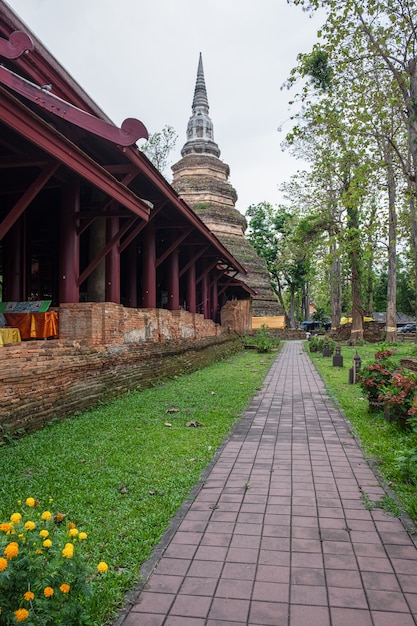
<box><xmin>0</xmin><ymin>59</ymin><xmax>148</xmax><ymax>147</ymax></box>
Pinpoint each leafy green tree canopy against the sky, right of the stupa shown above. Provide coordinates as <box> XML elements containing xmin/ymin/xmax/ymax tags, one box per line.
<box><xmin>286</xmin><ymin>0</ymin><xmax>417</xmax><ymax>337</ymax></box>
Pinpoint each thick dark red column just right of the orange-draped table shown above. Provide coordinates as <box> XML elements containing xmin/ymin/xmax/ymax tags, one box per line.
<box><xmin>59</xmin><ymin>177</ymin><xmax>80</xmax><ymax>303</ymax></box>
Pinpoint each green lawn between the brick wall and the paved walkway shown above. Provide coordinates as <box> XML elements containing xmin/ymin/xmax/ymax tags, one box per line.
<box><xmin>0</xmin><ymin>350</ymin><xmax>276</xmax><ymax>626</ymax></box>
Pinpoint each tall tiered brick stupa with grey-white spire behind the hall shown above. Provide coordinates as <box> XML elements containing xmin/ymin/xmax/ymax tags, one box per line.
<box><xmin>172</xmin><ymin>53</ymin><xmax>282</xmax><ymax>317</ymax></box>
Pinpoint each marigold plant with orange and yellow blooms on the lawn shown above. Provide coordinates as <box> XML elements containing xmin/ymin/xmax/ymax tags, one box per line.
<box><xmin>0</xmin><ymin>496</ymin><xmax>108</xmax><ymax>626</ymax></box>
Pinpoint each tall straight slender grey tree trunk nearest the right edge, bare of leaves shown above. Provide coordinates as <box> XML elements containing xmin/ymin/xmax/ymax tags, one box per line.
<box><xmin>385</xmin><ymin>147</ymin><xmax>397</xmax><ymax>342</ymax></box>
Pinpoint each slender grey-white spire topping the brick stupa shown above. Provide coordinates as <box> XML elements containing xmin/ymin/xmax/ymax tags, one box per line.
<box><xmin>181</xmin><ymin>52</ymin><xmax>220</xmax><ymax>157</ymax></box>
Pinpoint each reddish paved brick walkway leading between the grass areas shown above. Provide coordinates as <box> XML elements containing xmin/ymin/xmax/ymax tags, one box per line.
<box><xmin>115</xmin><ymin>342</ymin><xmax>417</xmax><ymax>626</ymax></box>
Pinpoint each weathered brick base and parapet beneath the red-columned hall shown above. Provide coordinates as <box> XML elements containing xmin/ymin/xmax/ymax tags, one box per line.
<box><xmin>0</xmin><ymin>303</ymin><xmax>242</xmax><ymax>434</ymax></box>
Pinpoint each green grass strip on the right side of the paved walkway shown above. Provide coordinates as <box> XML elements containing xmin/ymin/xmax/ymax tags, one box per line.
<box><xmin>305</xmin><ymin>343</ymin><xmax>417</xmax><ymax>522</ymax></box>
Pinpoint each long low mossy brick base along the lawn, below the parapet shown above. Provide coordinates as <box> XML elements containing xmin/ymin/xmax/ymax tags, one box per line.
<box><xmin>0</xmin><ymin>332</ymin><xmax>242</xmax><ymax>436</ymax></box>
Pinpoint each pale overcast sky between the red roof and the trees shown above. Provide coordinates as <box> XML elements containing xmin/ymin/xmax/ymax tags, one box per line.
<box><xmin>7</xmin><ymin>0</ymin><xmax>321</xmax><ymax>213</ymax></box>
